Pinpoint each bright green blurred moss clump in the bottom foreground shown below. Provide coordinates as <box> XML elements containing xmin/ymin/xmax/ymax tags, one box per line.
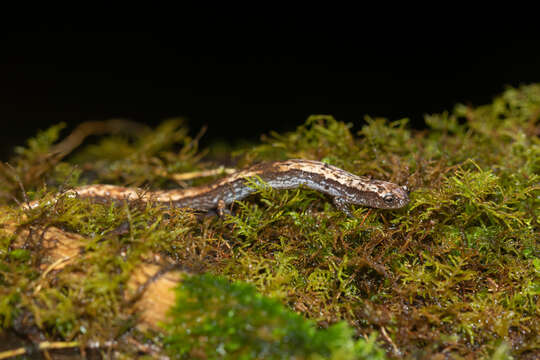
<box><xmin>165</xmin><ymin>275</ymin><xmax>385</xmax><ymax>359</ymax></box>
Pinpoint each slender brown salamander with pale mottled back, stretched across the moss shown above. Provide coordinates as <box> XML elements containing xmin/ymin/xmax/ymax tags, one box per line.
<box><xmin>30</xmin><ymin>160</ymin><xmax>409</xmax><ymax>215</ymax></box>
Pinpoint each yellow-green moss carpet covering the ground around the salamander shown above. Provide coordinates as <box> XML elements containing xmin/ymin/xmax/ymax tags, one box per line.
<box><xmin>0</xmin><ymin>85</ymin><xmax>540</xmax><ymax>359</ymax></box>
